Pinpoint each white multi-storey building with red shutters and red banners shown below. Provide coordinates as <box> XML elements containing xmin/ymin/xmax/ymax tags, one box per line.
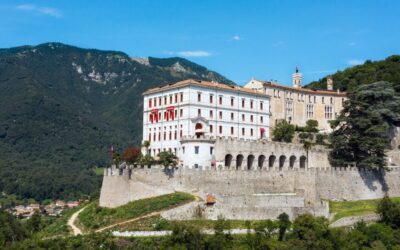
<box><xmin>143</xmin><ymin>80</ymin><xmax>270</xmax><ymax>165</ymax></box>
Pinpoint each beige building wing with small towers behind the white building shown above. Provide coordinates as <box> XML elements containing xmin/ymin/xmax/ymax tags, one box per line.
<box><xmin>244</xmin><ymin>67</ymin><xmax>346</xmax><ymax>132</ymax></box>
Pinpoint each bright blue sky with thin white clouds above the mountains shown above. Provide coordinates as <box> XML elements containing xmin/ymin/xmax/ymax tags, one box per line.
<box><xmin>0</xmin><ymin>0</ymin><xmax>400</xmax><ymax>84</ymax></box>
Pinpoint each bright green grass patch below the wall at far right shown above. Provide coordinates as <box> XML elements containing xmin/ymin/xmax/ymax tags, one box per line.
<box><xmin>329</xmin><ymin>197</ymin><xmax>400</xmax><ymax>221</ymax></box>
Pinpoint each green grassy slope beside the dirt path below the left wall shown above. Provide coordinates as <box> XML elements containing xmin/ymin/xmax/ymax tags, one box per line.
<box><xmin>79</xmin><ymin>192</ymin><xmax>195</xmax><ymax>230</ymax></box>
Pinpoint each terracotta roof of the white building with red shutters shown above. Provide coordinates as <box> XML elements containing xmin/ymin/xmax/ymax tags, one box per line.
<box><xmin>143</xmin><ymin>79</ymin><xmax>270</xmax><ymax>97</ymax></box>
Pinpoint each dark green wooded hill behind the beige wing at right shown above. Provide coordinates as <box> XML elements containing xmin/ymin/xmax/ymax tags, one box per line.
<box><xmin>306</xmin><ymin>55</ymin><xmax>400</xmax><ymax>92</ymax></box>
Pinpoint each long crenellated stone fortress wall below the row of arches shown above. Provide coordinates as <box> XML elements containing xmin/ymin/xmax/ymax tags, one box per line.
<box><xmin>100</xmin><ymin>167</ymin><xmax>400</xmax><ymax>219</ymax></box>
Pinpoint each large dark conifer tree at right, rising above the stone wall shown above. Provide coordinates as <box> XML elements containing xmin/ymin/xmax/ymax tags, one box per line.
<box><xmin>329</xmin><ymin>82</ymin><xmax>400</xmax><ymax>169</ymax></box>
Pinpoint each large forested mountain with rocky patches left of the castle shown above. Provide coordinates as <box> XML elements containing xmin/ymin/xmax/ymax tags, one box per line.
<box><xmin>0</xmin><ymin>43</ymin><xmax>233</xmax><ymax>200</ymax></box>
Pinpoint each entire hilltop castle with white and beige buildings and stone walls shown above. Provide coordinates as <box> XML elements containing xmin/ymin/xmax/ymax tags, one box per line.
<box><xmin>100</xmin><ymin>69</ymin><xmax>400</xmax><ymax>219</ymax></box>
